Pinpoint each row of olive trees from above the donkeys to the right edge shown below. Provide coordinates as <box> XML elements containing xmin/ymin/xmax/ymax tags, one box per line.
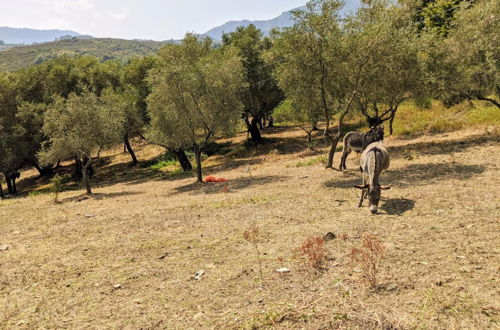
<box><xmin>268</xmin><ymin>0</ymin><xmax>500</xmax><ymax>162</ymax></box>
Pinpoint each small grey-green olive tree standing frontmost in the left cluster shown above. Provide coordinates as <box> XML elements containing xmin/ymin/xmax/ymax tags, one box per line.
<box><xmin>39</xmin><ymin>92</ymin><xmax>124</xmax><ymax>194</ymax></box>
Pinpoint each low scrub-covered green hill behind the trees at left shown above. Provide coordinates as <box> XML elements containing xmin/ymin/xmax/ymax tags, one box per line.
<box><xmin>0</xmin><ymin>38</ymin><xmax>166</xmax><ymax>71</ymax></box>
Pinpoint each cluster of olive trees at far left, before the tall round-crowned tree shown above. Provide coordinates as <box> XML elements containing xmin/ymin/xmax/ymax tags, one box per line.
<box><xmin>0</xmin><ymin>56</ymin><xmax>156</xmax><ymax>193</ymax></box>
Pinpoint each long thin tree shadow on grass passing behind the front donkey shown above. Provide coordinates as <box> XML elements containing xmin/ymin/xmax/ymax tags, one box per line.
<box><xmin>323</xmin><ymin>163</ymin><xmax>487</xmax><ymax>189</ymax></box>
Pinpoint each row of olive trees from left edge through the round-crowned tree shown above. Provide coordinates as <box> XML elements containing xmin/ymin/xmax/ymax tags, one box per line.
<box><xmin>0</xmin><ymin>35</ymin><xmax>247</xmax><ymax>193</ymax></box>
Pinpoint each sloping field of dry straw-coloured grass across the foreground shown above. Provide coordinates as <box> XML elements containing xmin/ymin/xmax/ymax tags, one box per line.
<box><xmin>0</xmin><ymin>128</ymin><xmax>500</xmax><ymax>329</ymax></box>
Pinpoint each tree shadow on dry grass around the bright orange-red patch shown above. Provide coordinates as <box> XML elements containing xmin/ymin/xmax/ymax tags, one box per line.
<box><xmin>172</xmin><ymin>175</ymin><xmax>289</xmax><ymax>195</ymax></box>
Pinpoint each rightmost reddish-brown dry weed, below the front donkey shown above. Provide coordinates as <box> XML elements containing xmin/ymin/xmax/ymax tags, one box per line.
<box><xmin>351</xmin><ymin>233</ymin><xmax>385</xmax><ymax>288</ymax></box>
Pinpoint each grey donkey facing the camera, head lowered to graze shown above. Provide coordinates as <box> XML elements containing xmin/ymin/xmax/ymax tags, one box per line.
<box><xmin>354</xmin><ymin>141</ymin><xmax>390</xmax><ymax>214</ymax></box>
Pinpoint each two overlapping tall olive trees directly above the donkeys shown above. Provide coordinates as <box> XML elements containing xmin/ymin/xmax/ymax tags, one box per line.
<box><xmin>269</xmin><ymin>0</ymin><xmax>421</xmax><ymax>167</ymax></box>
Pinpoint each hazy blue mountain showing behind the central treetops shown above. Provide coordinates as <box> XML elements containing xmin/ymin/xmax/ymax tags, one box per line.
<box><xmin>203</xmin><ymin>0</ymin><xmax>361</xmax><ymax>40</ymax></box>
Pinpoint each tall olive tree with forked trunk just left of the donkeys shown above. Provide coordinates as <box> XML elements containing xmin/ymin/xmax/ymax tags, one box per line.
<box><xmin>268</xmin><ymin>0</ymin><xmax>361</xmax><ymax>168</ymax></box>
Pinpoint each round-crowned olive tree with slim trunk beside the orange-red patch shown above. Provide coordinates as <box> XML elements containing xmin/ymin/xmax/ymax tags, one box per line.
<box><xmin>147</xmin><ymin>34</ymin><xmax>244</xmax><ymax>182</ymax></box>
